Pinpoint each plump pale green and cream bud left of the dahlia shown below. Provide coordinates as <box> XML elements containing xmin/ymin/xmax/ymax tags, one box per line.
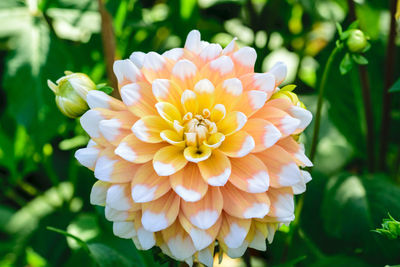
<box><xmin>47</xmin><ymin>71</ymin><xmax>96</xmax><ymax>118</ymax></box>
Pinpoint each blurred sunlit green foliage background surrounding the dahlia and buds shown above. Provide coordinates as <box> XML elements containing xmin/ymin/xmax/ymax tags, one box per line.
<box><xmin>0</xmin><ymin>0</ymin><xmax>400</xmax><ymax>267</ymax></box>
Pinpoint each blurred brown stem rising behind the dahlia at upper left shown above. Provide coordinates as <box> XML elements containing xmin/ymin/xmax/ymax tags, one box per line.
<box><xmin>97</xmin><ymin>0</ymin><xmax>120</xmax><ymax>98</ymax></box>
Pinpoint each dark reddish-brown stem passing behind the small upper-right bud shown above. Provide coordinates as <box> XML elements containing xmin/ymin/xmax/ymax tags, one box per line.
<box><xmin>347</xmin><ymin>0</ymin><xmax>375</xmax><ymax>172</ymax></box>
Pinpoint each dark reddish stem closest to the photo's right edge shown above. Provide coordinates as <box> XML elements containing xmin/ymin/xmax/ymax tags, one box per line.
<box><xmin>379</xmin><ymin>0</ymin><xmax>396</xmax><ymax>170</ymax></box>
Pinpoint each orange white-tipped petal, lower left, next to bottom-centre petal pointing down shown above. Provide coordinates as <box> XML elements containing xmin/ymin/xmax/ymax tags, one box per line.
<box><xmin>142</xmin><ymin>190</ymin><xmax>179</xmax><ymax>232</ymax></box>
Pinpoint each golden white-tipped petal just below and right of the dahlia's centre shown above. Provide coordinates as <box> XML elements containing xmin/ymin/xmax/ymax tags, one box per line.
<box><xmin>198</xmin><ymin>150</ymin><xmax>231</xmax><ymax>186</ymax></box>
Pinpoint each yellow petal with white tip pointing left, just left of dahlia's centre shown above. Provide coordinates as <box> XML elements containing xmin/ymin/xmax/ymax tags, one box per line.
<box><xmin>132</xmin><ymin>116</ymin><xmax>169</xmax><ymax>143</ymax></box>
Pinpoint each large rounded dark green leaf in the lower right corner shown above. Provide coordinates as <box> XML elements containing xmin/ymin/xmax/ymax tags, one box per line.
<box><xmin>321</xmin><ymin>173</ymin><xmax>400</xmax><ymax>263</ymax></box>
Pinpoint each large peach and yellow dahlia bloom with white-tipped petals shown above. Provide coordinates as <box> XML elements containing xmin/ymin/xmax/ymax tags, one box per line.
<box><xmin>75</xmin><ymin>31</ymin><xmax>312</xmax><ymax>266</ymax></box>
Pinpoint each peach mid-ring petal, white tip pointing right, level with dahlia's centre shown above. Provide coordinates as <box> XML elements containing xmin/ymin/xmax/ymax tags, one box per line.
<box><xmin>243</xmin><ymin>118</ymin><xmax>282</xmax><ymax>152</ymax></box>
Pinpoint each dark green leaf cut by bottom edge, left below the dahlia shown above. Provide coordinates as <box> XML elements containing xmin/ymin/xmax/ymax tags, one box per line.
<box><xmin>88</xmin><ymin>243</ymin><xmax>134</xmax><ymax>267</ymax></box>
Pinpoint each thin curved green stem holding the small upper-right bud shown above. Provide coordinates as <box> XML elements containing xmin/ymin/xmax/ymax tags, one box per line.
<box><xmin>310</xmin><ymin>47</ymin><xmax>341</xmax><ymax>161</ymax></box>
